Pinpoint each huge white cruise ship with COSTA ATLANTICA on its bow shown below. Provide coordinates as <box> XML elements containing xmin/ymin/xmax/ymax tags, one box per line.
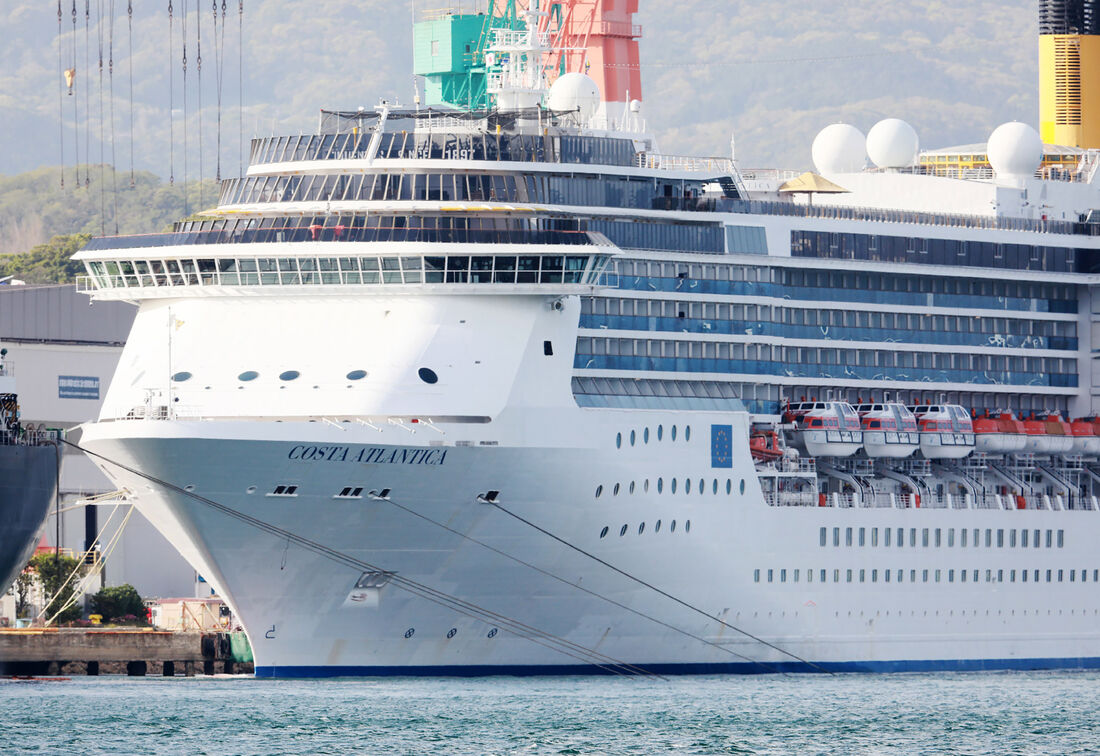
<box><xmin>70</xmin><ymin>0</ymin><xmax>1100</xmax><ymax>677</ymax></box>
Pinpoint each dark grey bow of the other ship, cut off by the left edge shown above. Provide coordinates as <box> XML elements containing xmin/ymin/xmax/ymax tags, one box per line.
<box><xmin>0</xmin><ymin>349</ymin><xmax>61</xmax><ymax>592</ymax></box>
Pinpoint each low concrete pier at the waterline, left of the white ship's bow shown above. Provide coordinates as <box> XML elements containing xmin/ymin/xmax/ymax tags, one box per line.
<box><xmin>0</xmin><ymin>628</ymin><xmax>252</xmax><ymax>677</ymax></box>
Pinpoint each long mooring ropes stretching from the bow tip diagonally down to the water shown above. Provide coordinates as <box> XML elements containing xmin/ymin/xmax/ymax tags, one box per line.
<box><xmin>62</xmin><ymin>439</ymin><xmax>663</xmax><ymax>679</ymax></box>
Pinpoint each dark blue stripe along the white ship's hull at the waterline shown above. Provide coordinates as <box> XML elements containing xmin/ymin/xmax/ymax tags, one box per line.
<box><xmin>256</xmin><ymin>656</ymin><xmax>1100</xmax><ymax>678</ymax></box>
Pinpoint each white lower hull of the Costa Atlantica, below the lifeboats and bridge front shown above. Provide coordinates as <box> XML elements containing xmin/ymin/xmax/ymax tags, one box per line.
<box><xmin>84</xmin><ymin>410</ymin><xmax>1100</xmax><ymax>676</ymax></box>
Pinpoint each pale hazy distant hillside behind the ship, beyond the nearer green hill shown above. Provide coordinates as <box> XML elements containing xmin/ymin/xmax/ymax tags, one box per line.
<box><xmin>0</xmin><ymin>0</ymin><xmax>1037</xmax><ymax>180</ymax></box>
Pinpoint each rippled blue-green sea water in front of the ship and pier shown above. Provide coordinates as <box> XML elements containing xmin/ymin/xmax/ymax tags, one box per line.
<box><xmin>0</xmin><ymin>672</ymin><xmax>1100</xmax><ymax>754</ymax></box>
